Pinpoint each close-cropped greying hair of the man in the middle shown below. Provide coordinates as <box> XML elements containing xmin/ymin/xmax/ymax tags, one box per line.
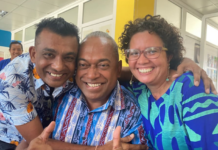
<box><xmin>81</xmin><ymin>31</ymin><xmax>119</xmax><ymax>60</ymax></box>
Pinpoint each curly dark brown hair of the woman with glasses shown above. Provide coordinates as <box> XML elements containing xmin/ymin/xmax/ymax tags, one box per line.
<box><xmin>119</xmin><ymin>15</ymin><xmax>185</xmax><ymax>70</ymax></box>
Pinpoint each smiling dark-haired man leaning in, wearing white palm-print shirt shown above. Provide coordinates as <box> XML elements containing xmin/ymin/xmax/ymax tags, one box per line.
<box><xmin>0</xmin><ymin>18</ymin><xmax>79</xmax><ymax>150</ymax></box>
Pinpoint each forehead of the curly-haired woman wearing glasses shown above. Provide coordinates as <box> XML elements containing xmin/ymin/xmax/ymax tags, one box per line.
<box><xmin>129</xmin><ymin>31</ymin><xmax>163</xmax><ymax>48</ymax></box>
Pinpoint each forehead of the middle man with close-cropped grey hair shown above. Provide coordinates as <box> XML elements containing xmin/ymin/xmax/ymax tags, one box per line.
<box><xmin>79</xmin><ymin>37</ymin><xmax>115</xmax><ymax>61</ymax></box>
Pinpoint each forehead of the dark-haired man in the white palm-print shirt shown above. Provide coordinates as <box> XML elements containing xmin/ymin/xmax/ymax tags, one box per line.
<box><xmin>35</xmin><ymin>29</ymin><xmax>78</xmax><ymax>51</ymax></box>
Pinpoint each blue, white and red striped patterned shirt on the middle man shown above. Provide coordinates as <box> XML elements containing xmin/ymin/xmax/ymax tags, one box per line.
<box><xmin>52</xmin><ymin>82</ymin><xmax>150</xmax><ymax>146</ymax></box>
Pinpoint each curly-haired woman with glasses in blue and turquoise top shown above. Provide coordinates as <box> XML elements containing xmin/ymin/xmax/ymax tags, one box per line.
<box><xmin>120</xmin><ymin>15</ymin><xmax>218</xmax><ymax>150</ymax></box>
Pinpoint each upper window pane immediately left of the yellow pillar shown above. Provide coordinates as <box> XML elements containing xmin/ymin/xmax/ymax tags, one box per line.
<box><xmin>83</xmin><ymin>0</ymin><xmax>114</xmax><ymax>23</ymax></box>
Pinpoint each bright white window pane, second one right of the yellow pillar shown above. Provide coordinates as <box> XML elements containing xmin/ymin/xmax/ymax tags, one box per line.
<box><xmin>186</xmin><ymin>13</ymin><xmax>202</xmax><ymax>38</ymax></box>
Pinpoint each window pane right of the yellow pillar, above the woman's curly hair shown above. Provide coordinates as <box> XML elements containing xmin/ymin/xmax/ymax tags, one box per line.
<box><xmin>156</xmin><ymin>0</ymin><xmax>182</xmax><ymax>28</ymax></box>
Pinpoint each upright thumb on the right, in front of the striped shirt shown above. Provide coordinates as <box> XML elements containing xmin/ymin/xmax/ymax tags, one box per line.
<box><xmin>113</xmin><ymin>126</ymin><xmax>123</xmax><ymax>150</ymax></box>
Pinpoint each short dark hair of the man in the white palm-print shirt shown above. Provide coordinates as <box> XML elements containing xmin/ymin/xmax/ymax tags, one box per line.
<box><xmin>35</xmin><ymin>18</ymin><xmax>79</xmax><ymax>45</ymax></box>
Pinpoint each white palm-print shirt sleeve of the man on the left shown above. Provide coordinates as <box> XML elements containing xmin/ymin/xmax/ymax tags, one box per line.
<box><xmin>0</xmin><ymin>59</ymin><xmax>37</xmax><ymax>126</ymax></box>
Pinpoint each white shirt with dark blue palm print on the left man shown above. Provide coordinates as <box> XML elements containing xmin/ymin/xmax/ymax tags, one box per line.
<box><xmin>0</xmin><ymin>54</ymin><xmax>74</xmax><ymax>145</ymax></box>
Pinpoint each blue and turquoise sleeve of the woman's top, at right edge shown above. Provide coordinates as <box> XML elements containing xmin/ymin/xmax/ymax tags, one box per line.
<box><xmin>182</xmin><ymin>76</ymin><xmax>218</xmax><ymax>150</ymax></box>
